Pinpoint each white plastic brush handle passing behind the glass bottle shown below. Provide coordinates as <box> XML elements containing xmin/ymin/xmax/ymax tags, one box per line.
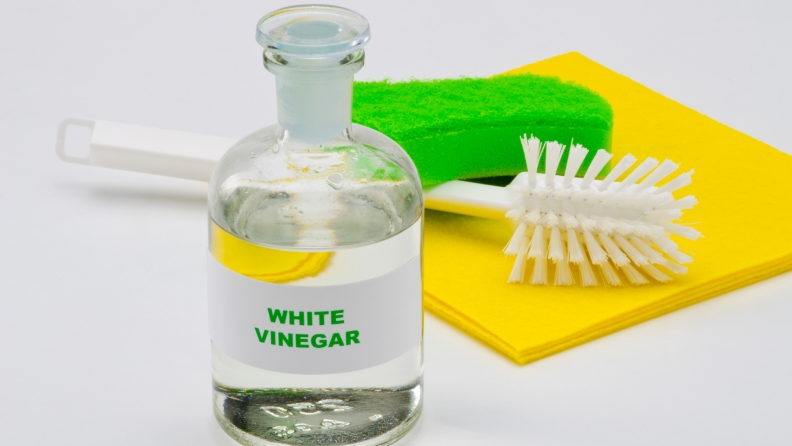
<box><xmin>55</xmin><ymin>118</ymin><xmax>518</xmax><ymax>220</ymax></box>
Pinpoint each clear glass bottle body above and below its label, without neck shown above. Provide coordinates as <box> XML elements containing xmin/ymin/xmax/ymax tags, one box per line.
<box><xmin>209</xmin><ymin>126</ymin><xmax>423</xmax><ymax>446</ymax></box>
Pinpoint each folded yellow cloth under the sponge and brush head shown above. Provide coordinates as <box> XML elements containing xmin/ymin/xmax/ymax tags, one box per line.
<box><xmin>424</xmin><ymin>53</ymin><xmax>792</xmax><ymax>364</ymax></box>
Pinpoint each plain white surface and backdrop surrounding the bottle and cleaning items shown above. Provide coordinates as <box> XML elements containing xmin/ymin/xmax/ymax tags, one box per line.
<box><xmin>0</xmin><ymin>0</ymin><xmax>792</xmax><ymax>446</ymax></box>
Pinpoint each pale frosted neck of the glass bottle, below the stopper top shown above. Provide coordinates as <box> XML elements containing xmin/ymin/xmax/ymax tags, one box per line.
<box><xmin>264</xmin><ymin>51</ymin><xmax>363</xmax><ymax>144</ymax></box>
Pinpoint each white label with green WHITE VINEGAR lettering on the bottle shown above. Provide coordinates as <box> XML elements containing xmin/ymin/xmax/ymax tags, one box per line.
<box><xmin>208</xmin><ymin>253</ymin><xmax>423</xmax><ymax>375</ymax></box>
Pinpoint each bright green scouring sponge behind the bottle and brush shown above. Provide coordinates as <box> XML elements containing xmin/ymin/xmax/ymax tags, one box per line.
<box><xmin>352</xmin><ymin>74</ymin><xmax>613</xmax><ymax>187</ymax></box>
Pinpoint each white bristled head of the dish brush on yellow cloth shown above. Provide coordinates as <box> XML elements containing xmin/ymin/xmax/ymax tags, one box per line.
<box><xmin>503</xmin><ymin>134</ymin><xmax>702</xmax><ymax>286</ymax></box>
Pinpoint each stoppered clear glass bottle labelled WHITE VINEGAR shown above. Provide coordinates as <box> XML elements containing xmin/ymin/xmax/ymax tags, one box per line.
<box><xmin>208</xmin><ymin>5</ymin><xmax>423</xmax><ymax>445</ymax></box>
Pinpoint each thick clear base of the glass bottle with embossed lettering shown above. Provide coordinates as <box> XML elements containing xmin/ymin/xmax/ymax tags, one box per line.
<box><xmin>213</xmin><ymin>381</ymin><xmax>422</xmax><ymax>446</ymax></box>
